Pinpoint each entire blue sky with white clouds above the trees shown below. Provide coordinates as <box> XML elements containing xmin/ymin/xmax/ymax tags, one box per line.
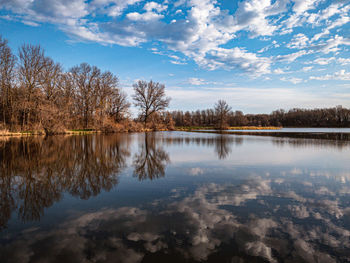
<box><xmin>0</xmin><ymin>0</ymin><xmax>350</xmax><ymax>113</ymax></box>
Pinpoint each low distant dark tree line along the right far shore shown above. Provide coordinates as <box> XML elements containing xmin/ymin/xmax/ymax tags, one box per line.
<box><xmin>171</xmin><ymin>105</ymin><xmax>350</xmax><ymax>129</ymax></box>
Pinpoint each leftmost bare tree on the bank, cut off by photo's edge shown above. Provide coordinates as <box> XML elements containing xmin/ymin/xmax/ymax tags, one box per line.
<box><xmin>0</xmin><ymin>36</ymin><xmax>16</xmax><ymax>129</ymax></box>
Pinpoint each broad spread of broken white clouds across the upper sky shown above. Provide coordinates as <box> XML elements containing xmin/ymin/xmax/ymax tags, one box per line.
<box><xmin>0</xmin><ymin>0</ymin><xmax>350</xmax><ymax>77</ymax></box>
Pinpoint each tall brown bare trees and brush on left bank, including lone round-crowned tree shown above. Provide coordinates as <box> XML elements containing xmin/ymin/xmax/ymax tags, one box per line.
<box><xmin>0</xmin><ymin>37</ymin><xmax>173</xmax><ymax>135</ymax></box>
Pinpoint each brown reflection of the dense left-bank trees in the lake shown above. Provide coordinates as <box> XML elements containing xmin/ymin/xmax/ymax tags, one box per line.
<box><xmin>0</xmin><ymin>135</ymin><xmax>130</xmax><ymax>228</ymax></box>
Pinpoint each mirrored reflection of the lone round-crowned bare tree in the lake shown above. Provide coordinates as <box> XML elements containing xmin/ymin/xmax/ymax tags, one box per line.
<box><xmin>133</xmin><ymin>133</ymin><xmax>170</xmax><ymax>180</ymax></box>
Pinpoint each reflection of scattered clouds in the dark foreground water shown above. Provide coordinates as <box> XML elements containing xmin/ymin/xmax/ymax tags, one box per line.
<box><xmin>2</xmin><ymin>176</ymin><xmax>350</xmax><ymax>262</ymax></box>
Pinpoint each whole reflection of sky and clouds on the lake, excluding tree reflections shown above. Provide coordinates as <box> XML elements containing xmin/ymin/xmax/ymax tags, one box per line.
<box><xmin>0</xmin><ymin>133</ymin><xmax>350</xmax><ymax>262</ymax></box>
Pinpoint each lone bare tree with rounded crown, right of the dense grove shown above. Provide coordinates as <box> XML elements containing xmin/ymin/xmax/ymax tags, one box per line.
<box><xmin>133</xmin><ymin>80</ymin><xmax>170</xmax><ymax>126</ymax></box>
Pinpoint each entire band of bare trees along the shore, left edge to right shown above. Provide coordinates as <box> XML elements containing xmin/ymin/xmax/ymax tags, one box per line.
<box><xmin>0</xmin><ymin>36</ymin><xmax>350</xmax><ymax>134</ymax></box>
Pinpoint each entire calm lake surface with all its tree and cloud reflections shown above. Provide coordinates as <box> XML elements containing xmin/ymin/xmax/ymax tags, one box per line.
<box><xmin>0</xmin><ymin>132</ymin><xmax>350</xmax><ymax>263</ymax></box>
